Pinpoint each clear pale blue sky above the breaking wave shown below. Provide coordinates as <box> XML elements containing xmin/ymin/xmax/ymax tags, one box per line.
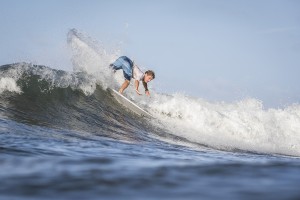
<box><xmin>0</xmin><ymin>0</ymin><xmax>300</xmax><ymax>108</ymax></box>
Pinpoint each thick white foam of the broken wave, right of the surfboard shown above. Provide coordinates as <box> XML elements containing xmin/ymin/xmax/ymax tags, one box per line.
<box><xmin>149</xmin><ymin>94</ymin><xmax>300</xmax><ymax>156</ymax></box>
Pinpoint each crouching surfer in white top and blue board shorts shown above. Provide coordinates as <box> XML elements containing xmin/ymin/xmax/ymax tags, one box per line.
<box><xmin>110</xmin><ymin>56</ymin><xmax>155</xmax><ymax>96</ymax></box>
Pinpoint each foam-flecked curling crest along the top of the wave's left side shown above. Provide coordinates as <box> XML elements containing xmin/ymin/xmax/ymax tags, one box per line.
<box><xmin>0</xmin><ymin>63</ymin><xmax>97</xmax><ymax>95</ymax></box>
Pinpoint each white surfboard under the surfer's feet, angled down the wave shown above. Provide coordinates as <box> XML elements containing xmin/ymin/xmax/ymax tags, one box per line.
<box><xmin>108</xmin><ymin>88</ymin><xmax>153</xmax><ymax>118</ymax></box>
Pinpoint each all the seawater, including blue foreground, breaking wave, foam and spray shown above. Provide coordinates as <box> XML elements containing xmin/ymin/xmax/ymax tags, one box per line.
<box><xmin>0</xmin><ymin>30</ymin><xmax>300</xmax><ymax>200</ymax></box>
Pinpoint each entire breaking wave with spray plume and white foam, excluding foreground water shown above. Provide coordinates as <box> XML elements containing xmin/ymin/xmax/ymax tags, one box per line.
<box><xmin>0</xmin><ymin>30</ymin><xmax>300</xmax><ymax>156</ymax></box>
